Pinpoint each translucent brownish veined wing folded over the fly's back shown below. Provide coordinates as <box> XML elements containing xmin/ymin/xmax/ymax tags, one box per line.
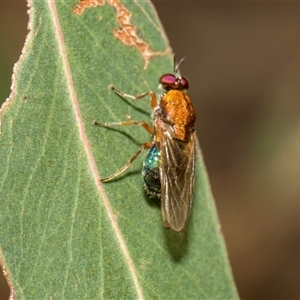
<box><xmin>160</xmin><ymin>127</ymin><xmax>196</xmax><ymax>231</ymax></box>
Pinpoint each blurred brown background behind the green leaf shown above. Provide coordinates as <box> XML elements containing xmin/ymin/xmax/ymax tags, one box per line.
<box><xmin>0</xmin><ymin>0</ymin><xmax>300</xmax><ymax>299</ymax></box>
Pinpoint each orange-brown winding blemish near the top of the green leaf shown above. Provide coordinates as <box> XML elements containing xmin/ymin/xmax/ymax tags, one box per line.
<box><xmin>73</xmin><ymin>0</ymin><xmax>170</xmax><ymax>70</ymax></box>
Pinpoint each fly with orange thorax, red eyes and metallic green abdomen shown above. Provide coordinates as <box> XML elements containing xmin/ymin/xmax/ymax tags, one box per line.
<box><xmin>94</xmin><ymin>59</ymin><xmax>196</xmax><ymax>231</ymax></box>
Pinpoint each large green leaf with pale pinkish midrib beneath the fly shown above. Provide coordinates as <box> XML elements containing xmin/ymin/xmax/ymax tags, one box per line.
<box><xmin>0</xmin><ymin>1</ymin><xmax>238</xmax><ymax>299</ymax></box>
